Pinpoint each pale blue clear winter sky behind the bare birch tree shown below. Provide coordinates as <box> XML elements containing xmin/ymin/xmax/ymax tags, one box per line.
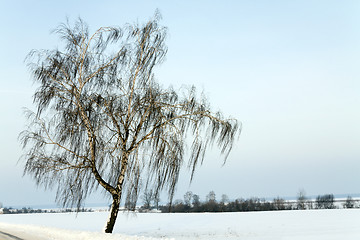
<box><xmin>0</xmin><ymin>0</ymin><xmax>360</xmax><ymax>205</ymax></box>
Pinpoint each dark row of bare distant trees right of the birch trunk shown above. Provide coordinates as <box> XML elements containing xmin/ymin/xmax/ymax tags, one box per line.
<box><xmin>139</xmin><ymin>191</ymin><xmax>359</xmax><ymax>213</ymax></box>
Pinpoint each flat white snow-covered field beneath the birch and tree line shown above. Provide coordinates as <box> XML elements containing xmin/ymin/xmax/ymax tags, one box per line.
<box><xmin>0</xmin><ymin>209</ymin><xmax>360</xmax><ymax>240</ymax></box>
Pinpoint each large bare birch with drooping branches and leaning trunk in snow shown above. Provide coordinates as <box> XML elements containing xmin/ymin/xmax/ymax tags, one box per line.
<box><xmin>20</xmin><ymin>13</ymin><xmax>240</xmax><ymax>233</ymax></box>
